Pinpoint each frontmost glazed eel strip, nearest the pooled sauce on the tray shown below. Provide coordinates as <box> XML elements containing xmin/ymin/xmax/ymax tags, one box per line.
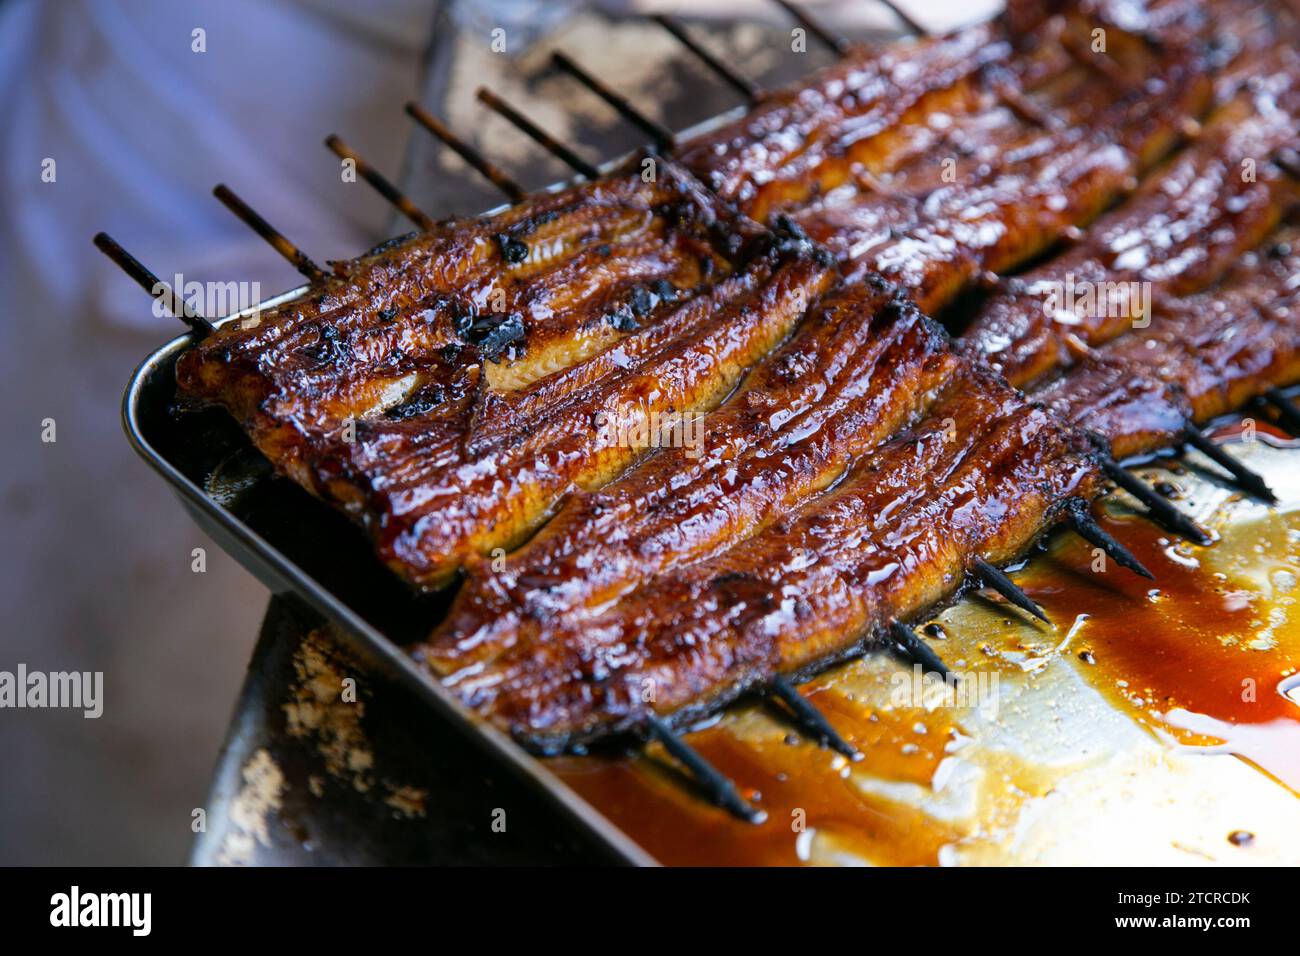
<box><xmin>416</xmin><ymin>363</ymin><xmax>1099</xmax><ymax>752</ymax></box>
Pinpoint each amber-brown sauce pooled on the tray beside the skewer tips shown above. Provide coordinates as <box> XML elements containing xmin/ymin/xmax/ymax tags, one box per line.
<box><xmin>549</xmin><ymin>442</ymin><xmax>1300</xmax><ymax>865</ymax></box>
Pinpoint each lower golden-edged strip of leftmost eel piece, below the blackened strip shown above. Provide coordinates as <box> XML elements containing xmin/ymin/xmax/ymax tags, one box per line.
<box><xmin>345</xmin><ymin>244</ymin><xmax>833</xmax><ymax>585</ymax></box>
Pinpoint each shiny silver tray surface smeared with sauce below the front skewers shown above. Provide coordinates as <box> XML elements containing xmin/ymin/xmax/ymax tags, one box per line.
<box><xmin>549</xmin><ymin>442</ymin><xmax>1300</xmax><ymax>866</ymax></box>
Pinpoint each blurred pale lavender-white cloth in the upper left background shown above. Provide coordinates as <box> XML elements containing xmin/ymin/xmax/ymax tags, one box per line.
<box><xmin>0</xmin><ymin>0</ymin><xmax>436</xmax><ymax>325</ymax></box>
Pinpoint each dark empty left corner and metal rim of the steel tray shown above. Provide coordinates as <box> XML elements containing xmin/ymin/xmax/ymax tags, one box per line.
<box><xmin>122</xmin><ymin>286</ymin><xmax>654</xmax><ymax>865</ymax></box>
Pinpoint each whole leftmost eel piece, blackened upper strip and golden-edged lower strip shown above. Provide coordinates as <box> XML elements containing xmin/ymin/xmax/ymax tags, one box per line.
<box><xmin>177</xmin><ymin>160</ymin><xmax>831</xmax><ymax>587</ymax></box>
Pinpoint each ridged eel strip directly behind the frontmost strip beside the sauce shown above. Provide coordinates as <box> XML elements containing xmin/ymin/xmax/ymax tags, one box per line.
<box><xmin>424</xmin><ymin>278</ymin><xmax>961</xmax><ymax>684</ymax></box>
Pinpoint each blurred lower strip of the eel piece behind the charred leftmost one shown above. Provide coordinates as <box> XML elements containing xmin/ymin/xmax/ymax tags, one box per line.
<box><xmin>796</xmin><ymin>43</ymin><xmax>1210</xmax><ymax>312</ymax></box>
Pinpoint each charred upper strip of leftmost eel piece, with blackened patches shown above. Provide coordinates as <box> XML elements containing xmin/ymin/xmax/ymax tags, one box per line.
<box><xmin>177</xmin><ymin>160</ymin><xmax>762</xmax><ymax>476</ymax></box>
